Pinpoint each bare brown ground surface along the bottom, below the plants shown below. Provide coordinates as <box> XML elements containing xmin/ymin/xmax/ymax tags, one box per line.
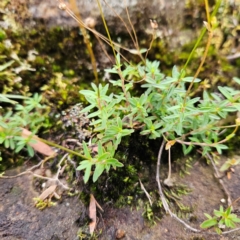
<box><xmin>0</xmin><ymin>157</ymin><xmax>240</xmax><ymax>240</ymax></box>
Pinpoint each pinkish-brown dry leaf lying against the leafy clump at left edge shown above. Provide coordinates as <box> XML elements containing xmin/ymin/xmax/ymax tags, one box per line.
<box><xmin>22</xmin><ymin>128</ymin><xmax>56</xmax><ymax>156</ymax></box>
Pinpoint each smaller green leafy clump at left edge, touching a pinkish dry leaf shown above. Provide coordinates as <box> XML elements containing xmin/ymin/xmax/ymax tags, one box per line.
<box><xmin>0</xmin><ymin>94</ymin><xmax>47</xmax><ymax>156</ymax></box>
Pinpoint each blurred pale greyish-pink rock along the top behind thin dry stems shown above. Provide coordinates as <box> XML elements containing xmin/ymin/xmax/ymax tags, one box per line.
<box><xmin>22</xmin><ymin>0</ymin><xmax>185</xmax><ymax>32</ymax></box>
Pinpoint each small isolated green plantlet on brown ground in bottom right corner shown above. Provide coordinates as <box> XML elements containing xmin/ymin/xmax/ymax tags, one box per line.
<box><xmin>200</xmin><ymin>206</ymin><xmax>240</xmax><ymax>234</ymax></box>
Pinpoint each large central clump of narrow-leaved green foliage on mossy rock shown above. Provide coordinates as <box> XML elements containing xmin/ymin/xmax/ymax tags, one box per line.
<box><xmin>79</xmin><ymin>57</ymin><xmax>240</xmax><ymax>182</ymax></box>
